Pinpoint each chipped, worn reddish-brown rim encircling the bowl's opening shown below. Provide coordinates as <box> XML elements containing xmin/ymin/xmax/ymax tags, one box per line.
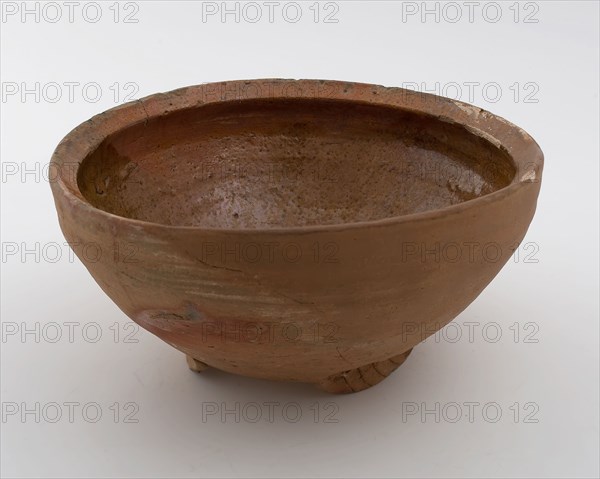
<box><xmin>49</xmin><ymin>78</ymin><xmax>544</xmax><ymax>234</ymax></box>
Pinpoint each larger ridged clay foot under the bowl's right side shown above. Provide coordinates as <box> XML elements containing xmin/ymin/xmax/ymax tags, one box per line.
<box><xmin>317</xmin><ymin>349</ymin><xmax>412</xmax><ymax>394</ymax></box>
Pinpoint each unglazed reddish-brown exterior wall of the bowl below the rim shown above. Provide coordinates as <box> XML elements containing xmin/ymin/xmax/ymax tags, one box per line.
<box><xmin>53</xmin><ymin>179</ymin><xmax>540</xmax><ymax>382</ymax></box>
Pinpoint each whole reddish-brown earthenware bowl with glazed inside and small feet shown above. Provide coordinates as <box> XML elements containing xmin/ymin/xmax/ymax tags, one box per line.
<box><xmin>51</xmin><ymin>80</ymin><xmax>543</xmax><ymax>393</ymax></box>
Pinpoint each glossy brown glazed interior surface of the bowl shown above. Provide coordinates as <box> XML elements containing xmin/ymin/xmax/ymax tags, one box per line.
<box><xmin>77</xmin><ymin>99</ymin><xmax>515</xmax><ymax>228</ymax></box>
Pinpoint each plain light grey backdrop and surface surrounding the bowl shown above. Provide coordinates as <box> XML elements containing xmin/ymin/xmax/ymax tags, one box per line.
<box><xmin>0</xmin><ymin>1</ymin><xmax>599</xmax><ymax>477</ymax></box>
